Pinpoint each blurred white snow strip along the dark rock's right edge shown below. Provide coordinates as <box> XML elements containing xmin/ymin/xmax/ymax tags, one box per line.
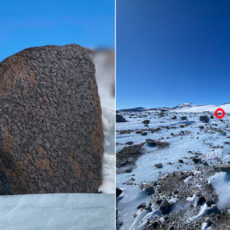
<box><xmin>92</xmin><ymin>51</ymin><xmax>116</xmax><ymax>193</ymax></box>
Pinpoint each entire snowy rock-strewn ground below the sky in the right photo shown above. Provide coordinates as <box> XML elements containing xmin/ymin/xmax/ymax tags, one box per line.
<box><xmin>116</xmin><ymin>103</ymin><xmax>230</xmax><ymax>230</ymax></box>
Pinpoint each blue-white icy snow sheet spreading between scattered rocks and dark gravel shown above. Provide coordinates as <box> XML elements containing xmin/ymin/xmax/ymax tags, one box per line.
<box><xmin>116</xmin><ymin>111</ymin><xmax>230</xmax><ymax>230</ymax></box>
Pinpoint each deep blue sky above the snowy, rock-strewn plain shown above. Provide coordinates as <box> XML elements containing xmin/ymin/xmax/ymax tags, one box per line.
<box><xmin>116</xmin><ymin>0</ymin><xmax>230</xmax><ymax>109</ymax></box>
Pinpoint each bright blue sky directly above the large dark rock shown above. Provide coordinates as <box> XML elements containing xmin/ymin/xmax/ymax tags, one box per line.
<box><xmin>0</xmin><ymin>0</ymin><xmax>115</xmax><ymax>61</ymax></box>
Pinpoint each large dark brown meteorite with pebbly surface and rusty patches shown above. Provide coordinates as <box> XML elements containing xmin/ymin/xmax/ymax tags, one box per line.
<box><xmin>0</xmin><ymin>45</ymin><xmax>103</xmax><ymax>194</ymax></box>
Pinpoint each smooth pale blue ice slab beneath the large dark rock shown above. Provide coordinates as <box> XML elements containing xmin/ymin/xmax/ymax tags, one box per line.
<box><xmin>0</xmin><ymin>194</ymin><xmax>115</xmax><ymax>230</ymax></box>
